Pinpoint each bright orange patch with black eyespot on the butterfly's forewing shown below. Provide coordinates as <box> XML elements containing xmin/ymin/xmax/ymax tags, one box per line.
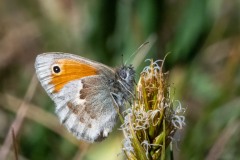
<box><xmin>50</xmin><ymin>59</ymin><xmax>97</xmax><ymax>93</ymax></box>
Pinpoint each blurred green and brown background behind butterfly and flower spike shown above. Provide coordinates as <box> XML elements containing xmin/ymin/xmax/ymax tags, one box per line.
<box><xmin>0</xmin><ymin>0</ymin><xmax>240</xmax><ymax>160</ymax></box>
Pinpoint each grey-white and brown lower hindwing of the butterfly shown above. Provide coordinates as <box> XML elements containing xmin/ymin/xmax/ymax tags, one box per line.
<box><xmin>56</xmin><ymin>76</ymin><xmax>117</xmax><ymax>142</ymax></box>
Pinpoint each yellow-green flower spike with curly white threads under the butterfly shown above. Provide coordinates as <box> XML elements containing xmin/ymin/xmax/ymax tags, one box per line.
<box><xmin>121</xmin><ymin>60</ymin><xmax>185</xmax><ymax>159</ymax></box>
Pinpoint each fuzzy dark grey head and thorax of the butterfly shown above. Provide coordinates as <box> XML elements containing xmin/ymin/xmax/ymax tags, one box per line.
<box><xmin>110</xmin><ymin>65</ymin><xmax>135</xmax><ymax>108</ymax></box>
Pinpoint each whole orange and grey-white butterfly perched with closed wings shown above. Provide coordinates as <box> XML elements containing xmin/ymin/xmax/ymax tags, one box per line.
<box><xmin>35</xmin><ymin>52</ymin><xmax>135</xmax><ymax>142</ymax></box>
